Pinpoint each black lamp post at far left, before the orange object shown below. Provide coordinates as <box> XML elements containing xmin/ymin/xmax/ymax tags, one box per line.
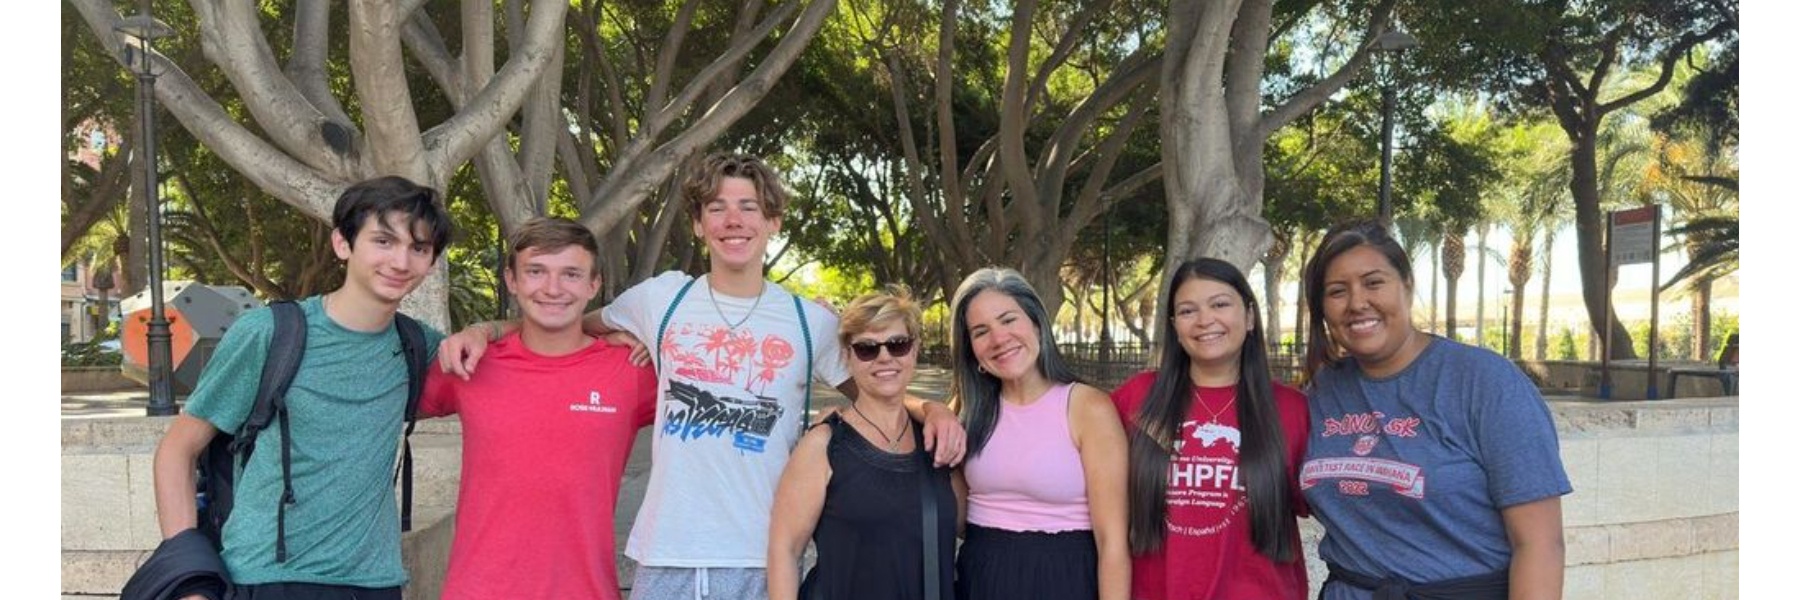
<box><xmin>113</xmin><ymin>7</ymin><xmax>175</xmax><ymax>416</ymax></box>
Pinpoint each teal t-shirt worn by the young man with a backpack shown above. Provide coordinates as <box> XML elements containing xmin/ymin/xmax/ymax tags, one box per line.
<box><xmin>185</xmin><ymin>295</ymin><xmax>443</xmax><ymax>587</ymax></box>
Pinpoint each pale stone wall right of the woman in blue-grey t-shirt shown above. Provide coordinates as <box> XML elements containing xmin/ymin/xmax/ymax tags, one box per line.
<box><xmin>1555</xmin><ymin>396</ymin><xmax>1739</xmax><ymax>598</ymax></box>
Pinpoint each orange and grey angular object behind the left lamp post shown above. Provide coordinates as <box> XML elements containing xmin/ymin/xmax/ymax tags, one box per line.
<box><xmin>119</xmin><ymin>281</ymin><xmax>263</xmax><ymax>396</ymax></box>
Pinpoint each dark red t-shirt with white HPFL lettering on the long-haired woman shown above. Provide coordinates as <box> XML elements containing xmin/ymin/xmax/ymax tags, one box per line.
<box><xmin>1112</xmin><ymin>371</ymin><xmax>1309</xmax><ymax>600</ymax></box>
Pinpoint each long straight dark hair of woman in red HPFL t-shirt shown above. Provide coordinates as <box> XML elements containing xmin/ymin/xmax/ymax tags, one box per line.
<box><xmin>1129</xmin><ymin>258</ymin><xmax>1300</xmax><ymax>562</ymax></box>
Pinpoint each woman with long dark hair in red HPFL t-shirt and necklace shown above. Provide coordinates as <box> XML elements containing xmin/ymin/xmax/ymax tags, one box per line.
<box><xmin>1112</xmin><ymin>258</ymin><xmax>1309</xmax><ymax>600</ymax></box>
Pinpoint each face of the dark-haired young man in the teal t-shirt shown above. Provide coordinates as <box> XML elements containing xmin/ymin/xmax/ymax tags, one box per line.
<box><xmin>331</xmin><ymin>211</ymin><xmax>437</xmax><ymax>305</ymax></box>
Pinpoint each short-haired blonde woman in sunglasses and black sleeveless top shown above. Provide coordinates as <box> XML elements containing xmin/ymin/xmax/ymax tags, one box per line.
<box><xmin>769</xmin><ymin>290</ymin><xmax>961</xmax><ymax>600</ymax></box>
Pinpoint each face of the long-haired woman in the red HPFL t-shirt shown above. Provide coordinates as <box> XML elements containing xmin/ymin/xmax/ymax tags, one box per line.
<box><xmin>1170</xmin><ymin>277</ymin><xmax>1255</xmax><ymax>380</ymax></box>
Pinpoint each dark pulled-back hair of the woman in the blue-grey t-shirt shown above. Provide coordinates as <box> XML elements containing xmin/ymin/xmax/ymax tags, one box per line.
<box><xmin>1301</xmin><ymin>220</ymin><xmax>1413</xmax><ymax>382</ymax></box>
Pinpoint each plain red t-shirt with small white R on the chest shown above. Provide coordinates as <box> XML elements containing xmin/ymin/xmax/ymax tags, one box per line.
<box><xmin>419</xmin><ymin>333</ymin><xmax>657</xmax><ymax>598</ymax></box>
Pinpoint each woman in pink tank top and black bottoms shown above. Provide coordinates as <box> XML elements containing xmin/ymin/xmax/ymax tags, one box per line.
<box><xmin>950</xmin><ymin>267</ymin><xmax>1130</xmax><ymax>600</ymax></box>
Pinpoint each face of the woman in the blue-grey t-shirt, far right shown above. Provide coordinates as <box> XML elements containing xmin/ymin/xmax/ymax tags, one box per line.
<box><xmin>1323</xmin><ymin>245</ymin><xmax>1424</xmax><ymax>377</ymax></box>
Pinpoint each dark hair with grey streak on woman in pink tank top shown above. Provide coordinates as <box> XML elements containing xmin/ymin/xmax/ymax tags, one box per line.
<box><xmin>950</xmin><ymin>267</ymin><xmax>1080</xmax><ymax>458</ymax></box>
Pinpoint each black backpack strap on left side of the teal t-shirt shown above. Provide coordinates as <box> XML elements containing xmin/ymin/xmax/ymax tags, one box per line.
<box><xmin>253</xmin><ymin>301</ymin><xmax>306</xmax><ymax>562</ymax></box>
